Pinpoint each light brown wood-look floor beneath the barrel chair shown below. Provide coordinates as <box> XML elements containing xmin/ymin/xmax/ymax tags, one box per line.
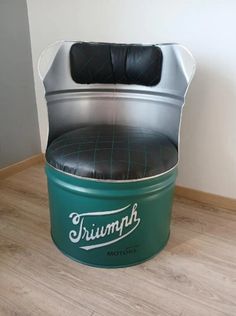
<box><xmin>0</xmin><ymin>165</ymin><xmax>236</xmax><ymax>316</ymax></box>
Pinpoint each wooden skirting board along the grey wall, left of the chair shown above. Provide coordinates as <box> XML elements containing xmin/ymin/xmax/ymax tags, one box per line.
<box><xmin>0</xmin><ymin>153</ymin><xmax>44</xmax><ymax>180</ymax></box>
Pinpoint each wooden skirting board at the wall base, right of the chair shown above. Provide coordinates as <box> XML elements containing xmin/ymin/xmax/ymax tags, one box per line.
<box><xmin>175</xmin><ymin>186</ymin><xmax>236</xmax><ymax>211</ymax></box>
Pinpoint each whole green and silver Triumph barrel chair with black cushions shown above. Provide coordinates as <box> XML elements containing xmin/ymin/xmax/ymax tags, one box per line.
<box><xmin>39</xmin><ymin>41</ymin><xmax>195</xmax><ymax>267</ymax></box>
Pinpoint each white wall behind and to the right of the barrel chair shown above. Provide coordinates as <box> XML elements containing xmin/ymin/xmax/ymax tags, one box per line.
<box><xmin>27</xmin><ymin>0</ymin><xmax>236</xmax><ymax>198</ymax></box>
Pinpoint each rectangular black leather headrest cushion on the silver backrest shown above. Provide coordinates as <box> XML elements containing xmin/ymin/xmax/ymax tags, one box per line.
<box><xmin>70</xmin><ymin>42</ymin><xmax>163</xmax><ymax>86</ymax></box>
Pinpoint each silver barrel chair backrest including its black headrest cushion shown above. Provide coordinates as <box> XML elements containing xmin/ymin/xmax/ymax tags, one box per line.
<box><xmin>39</xmin><ymin>41</ymin><xmax>195</xmax><ymax>146</ymax></box>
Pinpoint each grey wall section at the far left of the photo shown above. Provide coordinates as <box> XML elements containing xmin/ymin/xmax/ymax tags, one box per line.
<box><xmin>0</xmin><ymin>0</ymin><xmax>41</xmax><ymax>169</ymax></box>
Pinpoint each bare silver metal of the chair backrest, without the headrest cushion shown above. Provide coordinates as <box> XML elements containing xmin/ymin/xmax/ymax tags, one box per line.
<box><xmin>39</xmin><ymin>41</ymin><xmax>195</xmax><ymax>146</ymax></box>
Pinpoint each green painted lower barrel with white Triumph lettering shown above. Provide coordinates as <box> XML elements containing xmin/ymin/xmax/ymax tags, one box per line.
<box><xmin>46</xmin><ymin>165</ymin><xmax>177</xmax><ymax>267</ymax></box>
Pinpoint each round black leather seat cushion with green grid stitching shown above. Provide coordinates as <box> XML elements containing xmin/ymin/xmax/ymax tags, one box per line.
<box><xmin>46</xmin><ymin>125</ymin><xmax>178</xmax><ymax>180</ymax></box>
